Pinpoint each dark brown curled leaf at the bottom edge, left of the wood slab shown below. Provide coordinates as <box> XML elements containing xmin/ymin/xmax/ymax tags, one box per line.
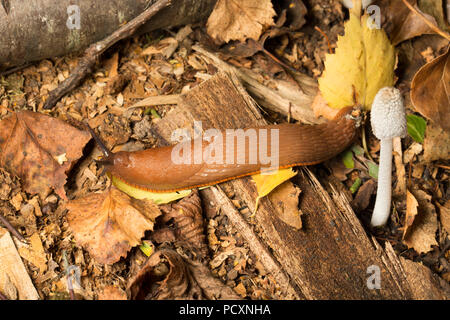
<box><xmin>127</xmin><ymin>249</ymin><xmax>202</xmax><ymax>300</ymax></box>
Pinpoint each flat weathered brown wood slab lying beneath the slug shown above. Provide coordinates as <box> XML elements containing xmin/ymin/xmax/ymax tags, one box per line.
<box><xmin>154</xmin><ymin>74</ymin><xmax>450</xmax><ymax>299</ymax></box>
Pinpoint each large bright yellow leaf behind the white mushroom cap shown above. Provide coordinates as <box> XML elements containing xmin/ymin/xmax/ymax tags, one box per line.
<box><xmin>319</xmin><ymin>10</ymin><xmax>395</xmax><ymax>110</ymax></box>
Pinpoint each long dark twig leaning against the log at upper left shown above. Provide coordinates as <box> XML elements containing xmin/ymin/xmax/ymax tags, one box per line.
<box><xmin>44</xmin><ymin>0</ymin><xmax>171</xmax><ymax>109</ymax></box>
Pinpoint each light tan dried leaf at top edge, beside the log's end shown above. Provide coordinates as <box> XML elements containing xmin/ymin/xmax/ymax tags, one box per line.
<box><xmin>206</xmin><ymin>0</ymin><xmax>275</xmax><ymax>44</ymax></box>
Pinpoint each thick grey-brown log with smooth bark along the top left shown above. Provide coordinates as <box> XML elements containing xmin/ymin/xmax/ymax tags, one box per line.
<box><xmin>0</xmin><ymin>0</ymin><xmax>216</xmax><ymax>69</ymax></box>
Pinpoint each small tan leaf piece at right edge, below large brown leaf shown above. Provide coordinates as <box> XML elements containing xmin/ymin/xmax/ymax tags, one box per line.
<box><xmin>423</xmin><ymin>123</ymin><xmax>450</xmax><ymax>162</ymax></box>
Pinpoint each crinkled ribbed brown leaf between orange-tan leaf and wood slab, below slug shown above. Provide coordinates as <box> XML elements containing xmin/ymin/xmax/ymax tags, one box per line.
<box><xmin>152</xmin><ymin>191</ymin><xmax>208</xmax><ymax>256</ymax></box>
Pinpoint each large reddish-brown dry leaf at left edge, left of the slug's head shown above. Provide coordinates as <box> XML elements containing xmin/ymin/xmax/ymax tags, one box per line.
<box><xmin>0</xmin><ymin>111</ymin><xmax>91</xmax><ymax>199</ymax></box>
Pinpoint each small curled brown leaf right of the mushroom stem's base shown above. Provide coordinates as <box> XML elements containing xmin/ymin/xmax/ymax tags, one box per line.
<box><xmin>403</xmin><ymin>190</ymin><xmax>438</xmax><ymax>253</ymax></box>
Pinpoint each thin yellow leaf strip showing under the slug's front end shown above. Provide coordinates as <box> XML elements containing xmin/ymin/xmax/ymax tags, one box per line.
<box><xmin>109</xmin><ymin>175</ymin><xmax>191</xmax><ymax>204</ymax></box>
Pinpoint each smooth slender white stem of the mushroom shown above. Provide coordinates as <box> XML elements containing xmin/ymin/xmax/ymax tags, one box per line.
<box><xmin>370</xmin><ymin>138</ymin><xmax>392</xmax><ymax>227</ymax></box>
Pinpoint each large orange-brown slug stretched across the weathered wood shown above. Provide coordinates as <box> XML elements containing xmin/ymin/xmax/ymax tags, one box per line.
<box><xmin>100</xmin><ymin>108</ymin><xmax>357</xmax><ymax>192</ymax></box>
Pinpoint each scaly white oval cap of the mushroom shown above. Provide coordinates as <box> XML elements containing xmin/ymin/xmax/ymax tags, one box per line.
<box><xmin>370</xmin><ymin>87</ymin><xmax>407</xmax><ymax>140</ymax></box>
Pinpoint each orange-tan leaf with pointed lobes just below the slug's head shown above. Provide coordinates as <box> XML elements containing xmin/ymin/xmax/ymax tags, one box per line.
<box><xmin>67</xmin><ymin>187</ymin><xmax>161</xmax><ymax>264</ymax></box>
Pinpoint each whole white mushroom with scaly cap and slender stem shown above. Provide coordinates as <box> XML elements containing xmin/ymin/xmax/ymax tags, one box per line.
<box><xmin>370</xmin><ymin>87</ymin><xmax>406</xmax><ymax>227</ymax></box>
